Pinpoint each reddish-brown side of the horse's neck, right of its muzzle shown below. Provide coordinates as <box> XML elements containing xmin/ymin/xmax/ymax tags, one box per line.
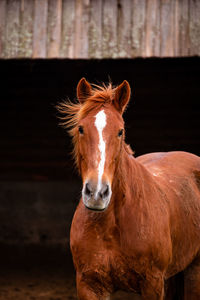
<box><xmin>108</xmin><ymin>147</ymin><xmax>162</xmax><ymax>253</ymax></box>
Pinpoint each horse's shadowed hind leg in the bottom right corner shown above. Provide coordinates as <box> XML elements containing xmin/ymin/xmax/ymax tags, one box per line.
<box><xmin>184</xmin><ymin>257</ymin><xmax>200</xmax><ymax>300</ymax></box>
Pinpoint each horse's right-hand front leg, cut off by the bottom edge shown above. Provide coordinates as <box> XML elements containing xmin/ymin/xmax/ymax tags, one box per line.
<box><xmin>141</xmin><ymin>272</ymin><xmax>164</xmax><ymax>300</ymax></box>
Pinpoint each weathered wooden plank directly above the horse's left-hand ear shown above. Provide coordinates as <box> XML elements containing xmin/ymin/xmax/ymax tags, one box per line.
<box><xmin>74</xmin><ymin>0</ymin><xmax>90</xmax><ymax>58</ymax></box>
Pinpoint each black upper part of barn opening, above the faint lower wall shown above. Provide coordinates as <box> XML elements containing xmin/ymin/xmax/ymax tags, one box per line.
<box><xmin>0</xmin><ymin>58</ymin><xmax>200</xmax><ymax>182</ymax></box>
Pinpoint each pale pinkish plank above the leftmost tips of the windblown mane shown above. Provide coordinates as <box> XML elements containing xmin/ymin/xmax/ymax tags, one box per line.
<box><xmin>47</xmin><ymin>0</ymin><xmax>62</xmax><ymax>58</ymax></box>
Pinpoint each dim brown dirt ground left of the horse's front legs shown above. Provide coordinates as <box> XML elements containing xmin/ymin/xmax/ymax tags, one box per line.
<box><xmin>0</xmin><ymin>269</ymin><xmax>76</xmax><ymax>300</ymax></box>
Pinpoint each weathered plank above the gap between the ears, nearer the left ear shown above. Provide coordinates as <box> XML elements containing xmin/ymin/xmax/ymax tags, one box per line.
<box><xmin>88</xmin><ymin>0</ymin><xmax>102</xmax><ymax>58</ymax></box>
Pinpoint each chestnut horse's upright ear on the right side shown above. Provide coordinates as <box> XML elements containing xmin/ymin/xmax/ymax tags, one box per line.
<box><xmin>113</xmin><ymin>80</ymin><xmax>131</xmax><ymax>113</ymax></box>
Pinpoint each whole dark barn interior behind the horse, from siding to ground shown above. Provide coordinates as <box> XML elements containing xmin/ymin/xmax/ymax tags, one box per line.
<box><xmin>0</xmin><ymin>57</ymin><xmax>200</xmax><ymax>294</ymax></box>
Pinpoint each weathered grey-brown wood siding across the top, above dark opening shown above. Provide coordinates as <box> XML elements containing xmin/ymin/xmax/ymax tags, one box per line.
<box><xmin>0</xmin><ymin>0</ymin><xmax>200</xmax><ymax>58</ymax></box>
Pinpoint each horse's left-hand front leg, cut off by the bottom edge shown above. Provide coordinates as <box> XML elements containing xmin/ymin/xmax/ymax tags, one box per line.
<box><xmin>76</xmin><ymin>274</ymin><xmax>110</xmax><ymax>300</ymax></box>
